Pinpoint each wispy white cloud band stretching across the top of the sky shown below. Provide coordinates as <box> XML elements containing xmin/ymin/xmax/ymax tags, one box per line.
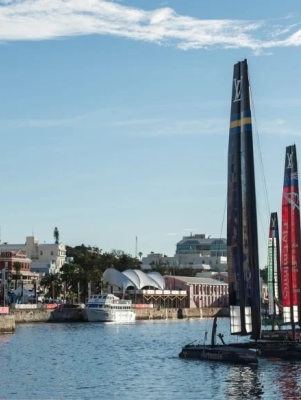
<box><xmin>0</xmin><ymin>0</ymin><xmax>301</xmax><ymax>52</ymax></box>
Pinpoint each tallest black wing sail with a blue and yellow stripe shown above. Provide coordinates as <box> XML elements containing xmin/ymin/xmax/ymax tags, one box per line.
<box><xmin>227</xmin><ymin>60</ymin><xmax>261</xmax><ymax>339</ymax></box>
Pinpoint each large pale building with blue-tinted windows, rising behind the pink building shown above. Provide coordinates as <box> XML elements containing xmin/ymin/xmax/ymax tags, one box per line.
<box><xmin>142</xmin><ymin>234</ymin><xmax>227</xmax><ymax>273</ymax></box>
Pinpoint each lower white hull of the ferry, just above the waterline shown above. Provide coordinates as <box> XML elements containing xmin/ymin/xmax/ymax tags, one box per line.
<box><xmin>83</xmin><ymin>308</ymin><xmax>136</xmax><ymax>322</ymax></box>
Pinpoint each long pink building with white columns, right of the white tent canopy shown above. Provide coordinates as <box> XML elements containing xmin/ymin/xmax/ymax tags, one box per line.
<box><xmin>164</xmin><ymin>275</ymin><xmax>229</xmax><ymax>308</ymax></box>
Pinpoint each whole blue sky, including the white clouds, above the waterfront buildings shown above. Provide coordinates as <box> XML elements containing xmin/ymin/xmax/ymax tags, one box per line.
<box><xmin>0</xmin><ymin>0</ymin><xmax>301</xmax><ymax>267</ymax></box>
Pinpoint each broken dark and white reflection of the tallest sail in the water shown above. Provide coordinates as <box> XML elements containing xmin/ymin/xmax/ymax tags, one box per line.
<box><xmin>225</xmin><ymin>365</ymin><xmax>264</xmax><ymax>399</ymax></box>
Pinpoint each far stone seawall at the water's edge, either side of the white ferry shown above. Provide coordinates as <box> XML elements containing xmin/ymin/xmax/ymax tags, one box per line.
<box><xmin>13</xmin><ymin>308</ymin><xmax>229</xmax><ymax>324</ymax></box>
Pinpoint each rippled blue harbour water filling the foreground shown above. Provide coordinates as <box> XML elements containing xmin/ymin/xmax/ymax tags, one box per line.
<box><xmin>0</xmin><ymin>319</ymin><xmax>301</xmax><ymax>400</ymax></box>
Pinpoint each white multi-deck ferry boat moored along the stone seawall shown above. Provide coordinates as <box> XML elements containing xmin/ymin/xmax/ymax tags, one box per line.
<box><xmin>83</xmin><ymin>294</ymin><xmax>136</xmax><ymax>322</ymax></box>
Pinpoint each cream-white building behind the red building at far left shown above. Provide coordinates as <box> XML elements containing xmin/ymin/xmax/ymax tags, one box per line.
<box><xmin>0</xmin><ymin>236</ymin><xmax>66</xmax><ymax>273</ymax></box>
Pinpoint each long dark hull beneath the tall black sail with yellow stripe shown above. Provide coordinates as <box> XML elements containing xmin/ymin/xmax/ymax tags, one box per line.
<box><xmin>179</xmin><ymin>345</ymin><xmax>258</xmax><ymax>364</ymax></box>
